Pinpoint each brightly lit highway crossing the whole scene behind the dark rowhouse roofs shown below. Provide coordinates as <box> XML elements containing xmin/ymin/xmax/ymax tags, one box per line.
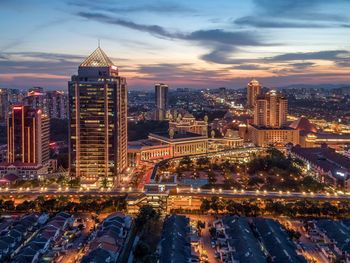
<box><xmin>0</xmin><ymin>185</ymin><xmax>350</xmax><ymax>201</ymax></box>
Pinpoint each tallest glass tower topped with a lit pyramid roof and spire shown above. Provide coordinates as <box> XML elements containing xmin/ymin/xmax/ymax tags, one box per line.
<box><xmin>68</xmin><ymin>47</ymin><xmax>127</xmax><ymax>184</ymax></box>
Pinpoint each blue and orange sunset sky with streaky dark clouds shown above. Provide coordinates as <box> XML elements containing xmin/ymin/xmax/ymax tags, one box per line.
<box><xmin>0</xmin><ymin>0</ymin><xmax>350</xmax><ymax>90</ymax></box>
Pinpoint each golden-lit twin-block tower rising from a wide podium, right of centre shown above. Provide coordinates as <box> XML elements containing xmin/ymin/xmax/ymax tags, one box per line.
<box><xmin>254</xmin><ymin>90</ymin><xmax>288</xmax><ymax>128</ymax></box>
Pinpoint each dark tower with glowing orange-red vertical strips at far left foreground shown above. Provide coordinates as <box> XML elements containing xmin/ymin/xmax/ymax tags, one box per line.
<box><xmin>7</xmin><ymin>105</ymin><xmax>50</xmax><ymax>165</ymax></box>
